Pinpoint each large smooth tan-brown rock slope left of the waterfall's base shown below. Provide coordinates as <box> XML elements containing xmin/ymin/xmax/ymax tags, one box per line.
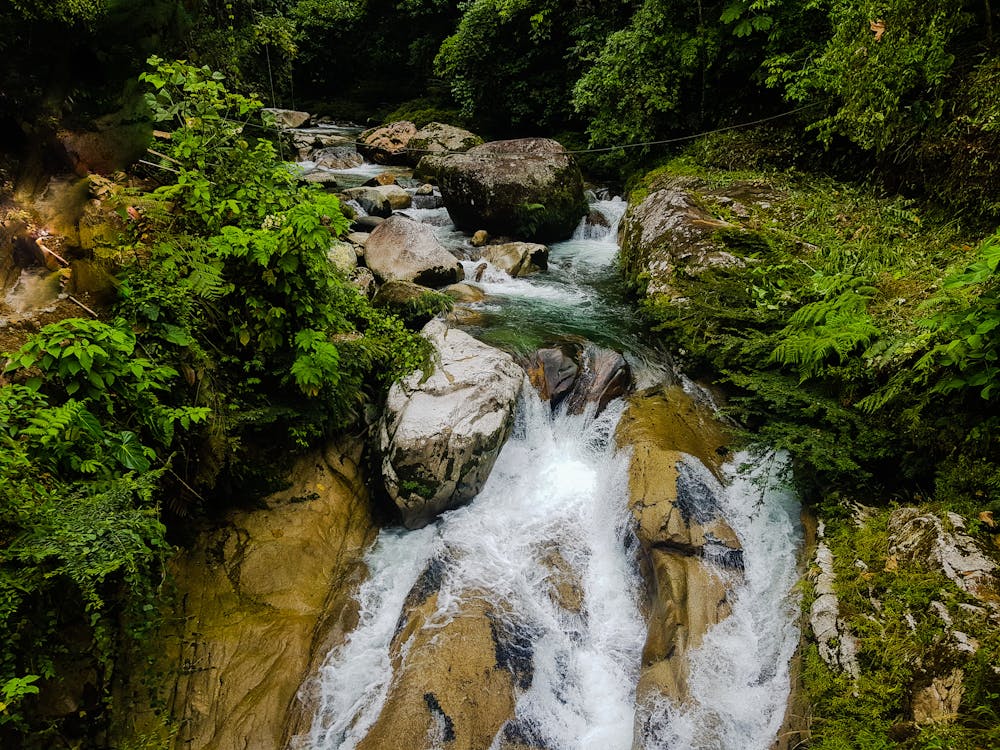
<box><xmin>121</xmin><ymin>441</ymin><xmax>377</xmax><ymax>750</ymax></box>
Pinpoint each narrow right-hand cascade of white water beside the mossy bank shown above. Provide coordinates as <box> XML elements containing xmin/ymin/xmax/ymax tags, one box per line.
<box><xmin>638</xmin><ymin>453</ymin><xmax>801</xmax><ymax>750</ymax></box>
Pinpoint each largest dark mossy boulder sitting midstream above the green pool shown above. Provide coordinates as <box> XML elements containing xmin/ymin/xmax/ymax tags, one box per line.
<box><xmin>436</xmin><ymin>138</ymin><xmax>587</xmax><ymax>242</ymax></box>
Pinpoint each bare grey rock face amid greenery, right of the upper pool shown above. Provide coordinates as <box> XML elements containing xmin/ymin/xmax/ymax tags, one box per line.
<box><xmin>618</xmin><ymin>177</ymin><xmax>742</xmax><ymax>301</ymax></box>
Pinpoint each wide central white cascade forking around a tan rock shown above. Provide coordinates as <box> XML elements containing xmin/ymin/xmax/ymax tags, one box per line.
<box><xmin>310</xmin><ymin>391</ymin><xmax>645</xmax><ymax>750</ymax></box>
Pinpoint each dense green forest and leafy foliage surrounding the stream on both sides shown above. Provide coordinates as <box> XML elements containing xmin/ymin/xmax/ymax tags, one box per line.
<box><xmin>0</xmin><ymin>0</ymin><xmax>1000</xmax><ymax>747</ymax></box>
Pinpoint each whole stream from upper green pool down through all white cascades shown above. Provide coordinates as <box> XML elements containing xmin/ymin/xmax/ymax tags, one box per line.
<box><xmin>292</xmin><ymin>148</ymin><xmax>801</xmax><ymax>750</ymax></box>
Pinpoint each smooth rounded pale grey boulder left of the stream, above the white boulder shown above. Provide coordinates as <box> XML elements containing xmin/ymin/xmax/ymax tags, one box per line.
<box><xmin>365</xmin><ymin>215</ymin><xmax>465</xmax><ymax>287</ymax></box>
